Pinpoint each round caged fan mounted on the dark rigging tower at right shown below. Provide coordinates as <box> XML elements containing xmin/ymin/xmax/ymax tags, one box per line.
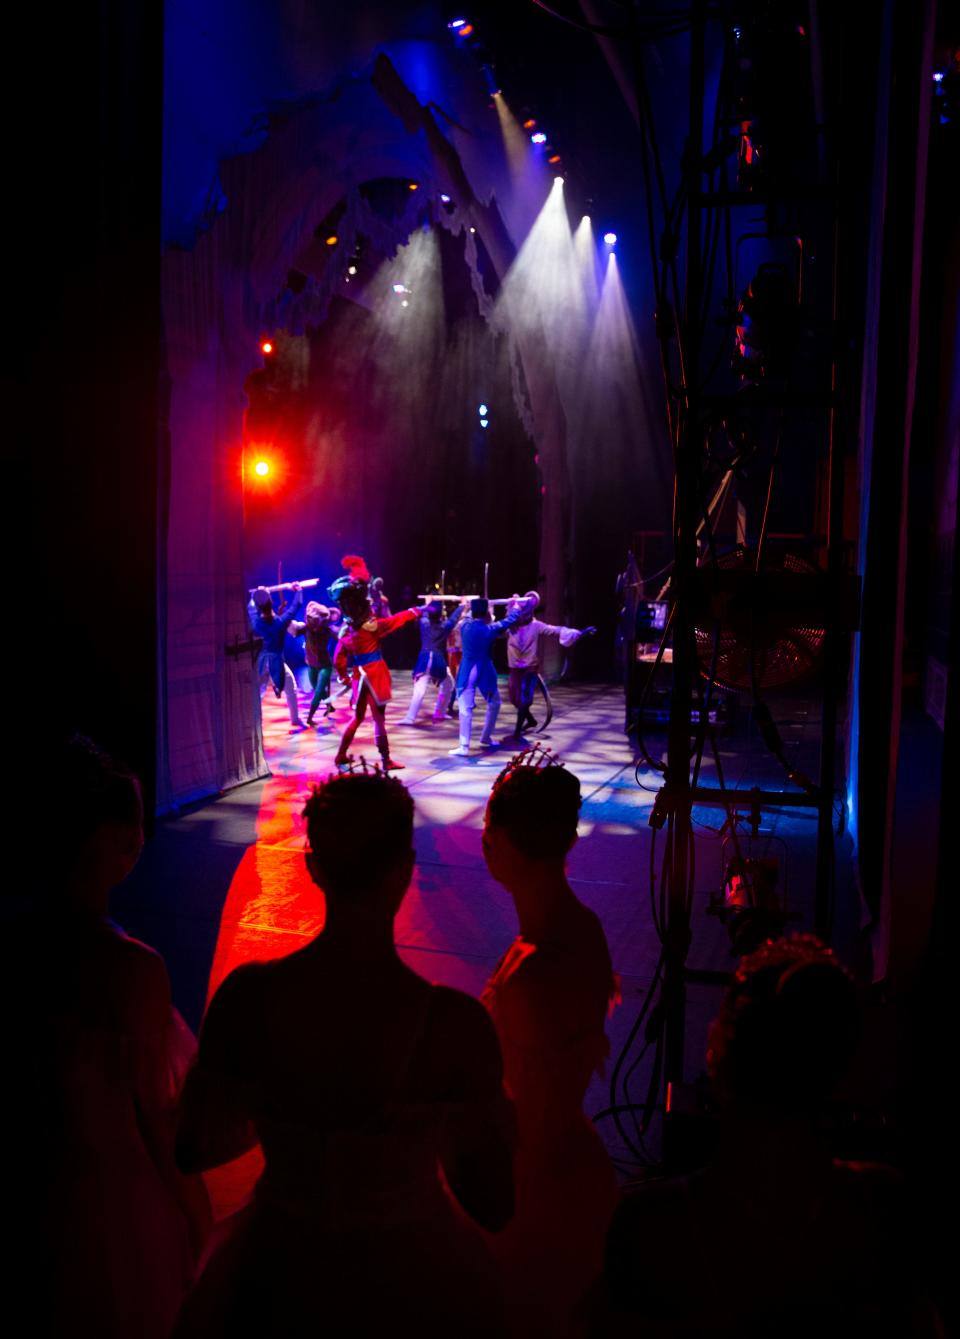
<box><xmin>696</xmin><ymin>545</ymin><xmax>825</xmax><ymax>692</ymax></box>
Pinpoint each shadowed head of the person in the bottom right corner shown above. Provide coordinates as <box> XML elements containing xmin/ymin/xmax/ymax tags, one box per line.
<box><xmin>707</xmin><ymin>935</ymin><xmax>860</xmax><ymax>1114</ymax></box>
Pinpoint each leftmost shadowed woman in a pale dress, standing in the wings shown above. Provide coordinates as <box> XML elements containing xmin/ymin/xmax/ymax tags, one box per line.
<box><xmin>21</xmin><ymin>735</ymin><xmax>212</xmax><ymax>1339</ymax></box>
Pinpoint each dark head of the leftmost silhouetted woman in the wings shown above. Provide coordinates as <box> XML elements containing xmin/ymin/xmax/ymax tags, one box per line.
<box><xmin>56</xmin><ymin>735</ymin><xmax>143</xmax><ymax>909</ymax></box>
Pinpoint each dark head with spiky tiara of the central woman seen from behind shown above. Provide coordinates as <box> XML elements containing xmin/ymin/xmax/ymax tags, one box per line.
<box><xmin>304</xmin><ymin>773</ymin><xmax>415</xmax><ymax>911</ymax></box>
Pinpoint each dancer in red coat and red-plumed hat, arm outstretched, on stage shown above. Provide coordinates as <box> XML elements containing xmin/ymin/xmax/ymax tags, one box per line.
<box><xmin>329</xmin><ymin>560</ymin><xmax>420</xmax><ymax>771</ymax></box>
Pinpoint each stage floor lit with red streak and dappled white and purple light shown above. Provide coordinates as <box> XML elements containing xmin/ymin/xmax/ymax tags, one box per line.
<box><xmin>116</xmin><ymin>674</ymin><xmax>857</xmax><ymax>1209</ymax></box>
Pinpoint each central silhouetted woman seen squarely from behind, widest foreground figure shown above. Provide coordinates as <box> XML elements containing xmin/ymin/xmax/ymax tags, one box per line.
<box><xmin>177</xmin><ymin>773</ymin><xmax>513</xmax><ymax>1339</ymax></box>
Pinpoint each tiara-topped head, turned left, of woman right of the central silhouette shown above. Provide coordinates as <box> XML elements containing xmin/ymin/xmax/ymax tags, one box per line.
<box><xmin>483</xmin><ymin>753</ymin><xmax>580</xmax><ymax>885</ymax></box>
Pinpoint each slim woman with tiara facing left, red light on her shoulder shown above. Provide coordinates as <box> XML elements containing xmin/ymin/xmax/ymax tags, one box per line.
<box><xmin>482</xmin><ymin>750</ymin><xmax>620</xmax><ymax>1339</ymax></box>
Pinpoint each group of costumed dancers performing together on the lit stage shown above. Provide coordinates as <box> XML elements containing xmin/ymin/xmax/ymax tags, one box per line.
<box><xmin>250</xmin><ymin>554</ymin><xmax>596</xmax><ymax>771</ymax></box>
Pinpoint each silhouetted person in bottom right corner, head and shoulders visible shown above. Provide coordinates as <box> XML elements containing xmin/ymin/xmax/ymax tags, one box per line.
<box><xmin>594</xmin><ymin>936</ymin><xmax>943</xmax><ymax>1339</ymax></box>
